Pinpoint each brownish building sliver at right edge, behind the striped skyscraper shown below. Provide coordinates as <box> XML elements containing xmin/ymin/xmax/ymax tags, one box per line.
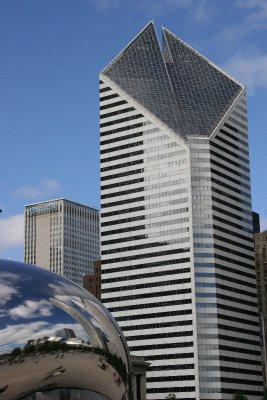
<box><xmin>254</xmin><ymin>230</ymin><xmax>267</xmax><ymax>383</ymax></box>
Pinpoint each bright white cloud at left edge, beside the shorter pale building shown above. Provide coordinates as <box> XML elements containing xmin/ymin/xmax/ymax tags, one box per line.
<box><xmin>0</xmin><ymin>214</ymin><xmax>24</xmax><ymax>251</ymax></box>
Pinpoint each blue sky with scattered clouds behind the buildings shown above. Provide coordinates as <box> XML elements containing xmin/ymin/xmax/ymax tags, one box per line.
<box><xmin>0</xmin><ymin>0</ymin><xmax>267</xmax><ymax>261</ymax></box>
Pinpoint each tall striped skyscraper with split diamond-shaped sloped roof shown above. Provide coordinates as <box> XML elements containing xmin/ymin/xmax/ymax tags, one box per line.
<box><xmin>100</xmin><ymin>23</ymin><xmax>262</xmax><ymax>400</ymax></box>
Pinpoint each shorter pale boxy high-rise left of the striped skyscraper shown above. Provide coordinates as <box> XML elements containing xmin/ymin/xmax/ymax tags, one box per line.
<box><xmin>24</xmin><ymin>199</ymin><xmax>100</xmax><ymax>285</ymax></box>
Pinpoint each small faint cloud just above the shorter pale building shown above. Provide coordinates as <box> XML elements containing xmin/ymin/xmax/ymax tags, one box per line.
<box><xmin>15</xmin><ymin>179</ymin><xmax>61</xmax><ymax>199</ymax></box>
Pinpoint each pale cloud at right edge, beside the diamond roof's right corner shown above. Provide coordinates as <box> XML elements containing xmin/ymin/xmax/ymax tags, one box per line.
<box><xmin>224</xmin><ymin>54</ymin><xmax>267</xmax><ymax>94</ymax></box>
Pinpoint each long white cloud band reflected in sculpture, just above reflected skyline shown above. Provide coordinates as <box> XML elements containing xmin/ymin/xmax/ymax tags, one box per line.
<box><xmin>0</xmin><ymin>321</ymin><xmax>85</xmax><ymax>354</ymax></box>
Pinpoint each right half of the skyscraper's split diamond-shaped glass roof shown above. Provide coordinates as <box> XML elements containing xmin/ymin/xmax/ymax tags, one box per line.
<box><xmin>163</xmin><ymin>29</ymin><xmax>242</xmax><ymax>135</ymax></box>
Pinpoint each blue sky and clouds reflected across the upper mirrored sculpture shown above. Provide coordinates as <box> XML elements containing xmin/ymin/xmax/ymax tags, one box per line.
<box><xmin>0</xmin><ymin>261</ymin><xmax>129</xmax><ymax>366</ymax></box>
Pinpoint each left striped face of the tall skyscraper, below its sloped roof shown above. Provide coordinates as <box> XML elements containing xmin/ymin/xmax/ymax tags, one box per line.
<box><xmin>100</xmin><ymin>77</ymin><xmax>199</xmax><ymax>399</ymax></box>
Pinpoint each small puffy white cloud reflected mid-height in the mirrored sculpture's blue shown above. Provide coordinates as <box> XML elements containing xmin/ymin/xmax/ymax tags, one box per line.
<box><xmin>9</xmin><ymin>300</ymin><xmax>52</xmax><ymax>319</ymax></box>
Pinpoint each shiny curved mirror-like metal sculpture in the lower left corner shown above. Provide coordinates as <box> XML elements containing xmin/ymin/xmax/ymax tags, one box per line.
<box><xmin>0</xmin><ymin>260</ymin><xmax>131</xmax><ymax>400</ymax></box>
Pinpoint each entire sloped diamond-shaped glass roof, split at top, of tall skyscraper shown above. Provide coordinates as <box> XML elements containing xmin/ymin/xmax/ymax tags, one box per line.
<box><xmin>102</xmin><ymin>22</ymin><xmax>242</xmax><ymax>136</ymax></box>
